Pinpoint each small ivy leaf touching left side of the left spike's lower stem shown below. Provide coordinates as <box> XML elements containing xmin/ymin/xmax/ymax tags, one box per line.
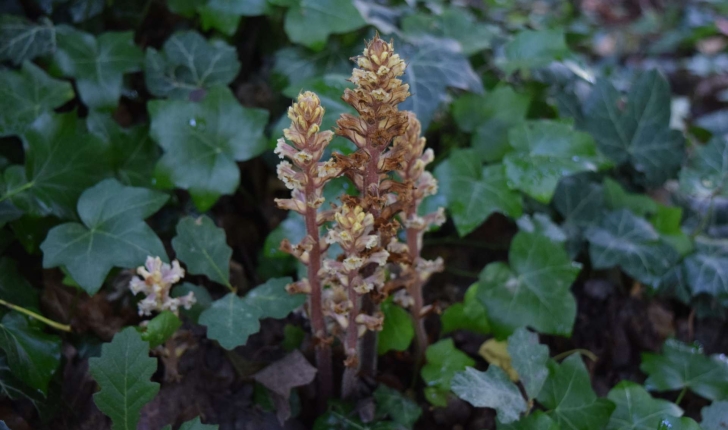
<box><xmin>244</xmin><ymin>278</ymin><xmax>306</xmax><ymax>319</ymax></box>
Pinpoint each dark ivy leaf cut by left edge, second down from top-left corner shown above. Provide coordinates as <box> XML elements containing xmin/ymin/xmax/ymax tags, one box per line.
<box><xmin>0</xmin><ymin>61</ymin><xmax>73</xmax><ymax>136</ymax></box>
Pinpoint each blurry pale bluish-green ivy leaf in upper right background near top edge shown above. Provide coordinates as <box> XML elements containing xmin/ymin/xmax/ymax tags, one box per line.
<box><xmin>501</xmin><ymin>28</ymin><xmax>571</xmax><ymax>74</ymax></box>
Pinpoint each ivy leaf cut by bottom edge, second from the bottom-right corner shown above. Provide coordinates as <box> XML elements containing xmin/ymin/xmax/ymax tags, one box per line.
<box><xmin>607</xmin><ymin>381</ymin><xmax>683</xmax><ymax>430</ymax></box>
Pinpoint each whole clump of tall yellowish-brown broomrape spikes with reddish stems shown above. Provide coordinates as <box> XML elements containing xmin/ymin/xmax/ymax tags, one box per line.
<box><xmin>275</xmin><ymin>36</ymin><xmax>445</xmax><ymax>398</ymax></box>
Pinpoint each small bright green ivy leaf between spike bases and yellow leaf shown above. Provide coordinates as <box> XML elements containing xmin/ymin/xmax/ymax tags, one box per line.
<box><xmin>420</xmin><ymin>338</ymin><xmax>475</xmax><ymax>407</ymax></box>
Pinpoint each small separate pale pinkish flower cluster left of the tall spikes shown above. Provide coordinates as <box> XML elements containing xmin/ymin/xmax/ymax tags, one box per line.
<box><xmin>129</xmin><ymin>257</ymin><xmax>197</xmax><ymax>316</ymax></box>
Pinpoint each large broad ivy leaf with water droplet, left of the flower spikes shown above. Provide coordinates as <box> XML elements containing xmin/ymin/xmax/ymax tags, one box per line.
<box><xmin>148</xmin><ymin>87</ymin><xmax>268</xmax><ymax>211</ymax></box>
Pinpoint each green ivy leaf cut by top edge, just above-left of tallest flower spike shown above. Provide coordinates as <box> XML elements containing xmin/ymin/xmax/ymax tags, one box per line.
<box><xmin>283</xmin><ymin>0</ymin><xmax>366</xmax><ymax>51</ymax></box>
